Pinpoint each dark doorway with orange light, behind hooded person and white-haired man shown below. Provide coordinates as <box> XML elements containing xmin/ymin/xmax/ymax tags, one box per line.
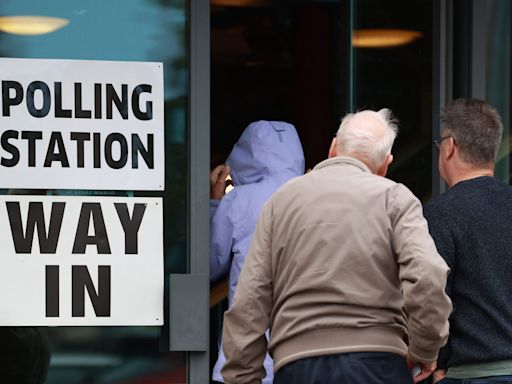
<box><xmin>210</xmin><ymin>0</ymin><xmax>434</xmax><ymax>380</ymax></box>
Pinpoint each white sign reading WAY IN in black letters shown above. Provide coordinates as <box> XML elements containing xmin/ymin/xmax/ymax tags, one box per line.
<box><xmin>0</xmin><ymin>195</ymin><xmax>163</xmax><ymax>326</ymax></box>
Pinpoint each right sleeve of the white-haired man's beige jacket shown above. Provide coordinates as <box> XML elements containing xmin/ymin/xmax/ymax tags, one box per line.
<box><xmin>391</xmin><ymin>185</ymin><xmax>452</xmax><ymax>362</ymax></box>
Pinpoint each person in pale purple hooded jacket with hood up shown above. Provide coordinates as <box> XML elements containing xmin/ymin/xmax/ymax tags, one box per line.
<box><xmin>210</xmin><ymin>121</ymin><xmax>304</xmax><ymax>384</ymax></box>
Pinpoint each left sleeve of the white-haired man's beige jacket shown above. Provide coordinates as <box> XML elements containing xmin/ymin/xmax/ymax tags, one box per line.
<box><xmin>222</xmin><ymin>203</ymin><xmax>272</xmax><ymax>384</ymax></box>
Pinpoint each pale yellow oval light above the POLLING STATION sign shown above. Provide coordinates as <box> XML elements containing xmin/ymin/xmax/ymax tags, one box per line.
<box><xmin>0</xmin><ymin>16</ymin><xmax>69</xmax><ymax>35</ymax></box>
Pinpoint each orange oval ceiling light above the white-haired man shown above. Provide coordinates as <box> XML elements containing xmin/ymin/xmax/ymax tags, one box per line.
<box><xmin>352</xmin><ymin>29</ymin><xmax>423</xmax><ymax>48</ymax></box>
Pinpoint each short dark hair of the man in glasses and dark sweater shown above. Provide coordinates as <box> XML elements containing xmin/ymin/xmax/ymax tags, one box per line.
<box><xmin>441</xmin><ymin>99</ymin><xmax>503</xmax><ymax>166</ymax></box>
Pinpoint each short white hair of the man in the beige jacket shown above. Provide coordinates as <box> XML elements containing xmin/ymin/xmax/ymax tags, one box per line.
<box><xmin>336</xmin><ymin>108</ymin><xmax>398</xmax><ymax>172</ymax></box>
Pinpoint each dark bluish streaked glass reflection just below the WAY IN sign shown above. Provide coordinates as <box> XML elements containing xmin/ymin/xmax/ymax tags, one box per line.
<box><xmin>46</xmin><ymin>327</ymin><xmax>186</xmax><ymax>384</ymax></box>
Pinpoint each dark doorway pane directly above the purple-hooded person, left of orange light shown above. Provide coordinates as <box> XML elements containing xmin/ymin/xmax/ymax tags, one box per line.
<box><xmin>211</xmin><ymin>0</ymin><xmax>350</xmax><ymax>168</ymax></box>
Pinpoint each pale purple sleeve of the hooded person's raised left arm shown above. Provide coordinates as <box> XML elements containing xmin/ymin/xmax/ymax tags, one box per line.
<box><xmin>210</xmin><ymin>195</ymin><xmax>235</xmax><ymax>281</ymax></box>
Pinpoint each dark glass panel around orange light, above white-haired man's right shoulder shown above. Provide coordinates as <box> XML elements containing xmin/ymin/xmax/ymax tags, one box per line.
<box><xmin>353</xmin><ymin>0</ymin><xmax>433</xmax><ymax>200</ymax></box>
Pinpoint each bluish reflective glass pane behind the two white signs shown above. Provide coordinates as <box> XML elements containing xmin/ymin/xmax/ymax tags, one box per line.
<box><xmin>0</xmin><ymin>0</ymin><xmax>188</xmax><ymax>384</ymax></box>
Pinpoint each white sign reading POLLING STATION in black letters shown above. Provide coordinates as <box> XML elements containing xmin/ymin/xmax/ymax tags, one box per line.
<box><xmin>0</xmin><ymin>58</ymin><xmax>165</xmax><ymax>190</ymax></box>
